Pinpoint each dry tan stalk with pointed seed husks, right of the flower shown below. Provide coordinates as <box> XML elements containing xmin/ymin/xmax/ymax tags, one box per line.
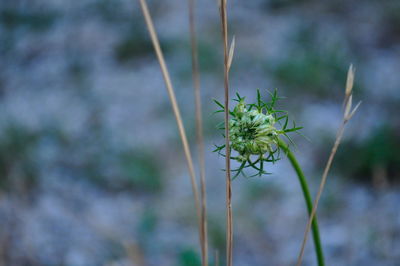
<box><xmin>296</xmin><ymin>65</ymin><xmax>361</xmax><ymax>266</ymax></box>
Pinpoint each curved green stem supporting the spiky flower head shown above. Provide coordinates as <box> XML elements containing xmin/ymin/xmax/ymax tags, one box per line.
<box><xmin>279</xmin><ymin>139</ymin><xmax>325</xmax><ymax>266</ymax></box>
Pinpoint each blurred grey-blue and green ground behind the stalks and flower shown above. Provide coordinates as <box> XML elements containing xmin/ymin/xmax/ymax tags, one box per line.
<box><xmin>0</xmin><ymin>0</ymin><xmax>400</xmax><ymax>266</ymax></box>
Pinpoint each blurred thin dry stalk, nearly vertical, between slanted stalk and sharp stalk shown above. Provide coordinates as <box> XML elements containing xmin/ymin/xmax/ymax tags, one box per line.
<box><xmin>189</xmin><ymin>0</ymin><xmax>208</xmax><ymax>266</ymax></box>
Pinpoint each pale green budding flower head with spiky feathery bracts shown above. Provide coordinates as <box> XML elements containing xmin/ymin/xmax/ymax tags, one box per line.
<box><xmin>214</xmin><ymin>90</ymin><xmax>301</xmax><ymax>178</ymax></box>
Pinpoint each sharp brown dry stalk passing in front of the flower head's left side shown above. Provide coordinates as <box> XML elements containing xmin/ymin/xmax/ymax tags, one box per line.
<box><xmin>220</xmin><ymin>0</ymin><xmax>234</xmax><ymax>266</ymax></box>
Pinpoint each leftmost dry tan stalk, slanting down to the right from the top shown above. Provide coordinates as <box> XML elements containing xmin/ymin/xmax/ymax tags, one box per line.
<box><xmin>139</xmin><ymin>0</ymin><xmax>202</xmax><ymax>254</ymax></box>
